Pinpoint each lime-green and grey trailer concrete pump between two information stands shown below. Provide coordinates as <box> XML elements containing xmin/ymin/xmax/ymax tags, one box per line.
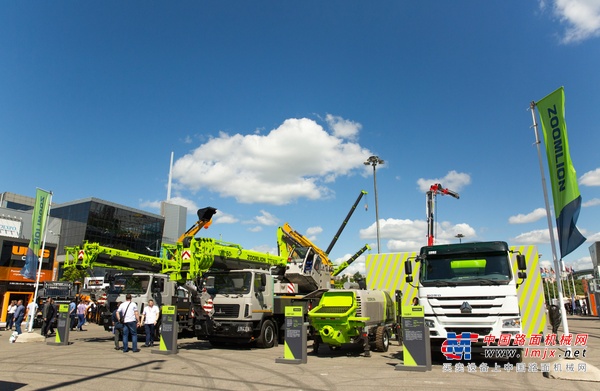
<box><xmin>308</xmin><ymin>289</ymin><xmax>396</xmax><ymax>356</ymax></box>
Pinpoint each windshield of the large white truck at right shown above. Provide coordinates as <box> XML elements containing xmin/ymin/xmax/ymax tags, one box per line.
<box><xmin>420</xmin><ymin>253</ymin><xmax>512</xmax><ymax>286</ymax></box>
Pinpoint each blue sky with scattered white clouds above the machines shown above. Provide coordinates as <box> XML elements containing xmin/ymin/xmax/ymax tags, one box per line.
<box><xmin>0</xmin><ymin>0</ymin><xmax>600</xmax><ymax>272</ymax></box>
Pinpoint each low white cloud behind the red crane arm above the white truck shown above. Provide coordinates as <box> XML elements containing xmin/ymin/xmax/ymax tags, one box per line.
<box><xmin>359</xmin><ymin>219</ymin><xmax>477</xmax><ymax>252</ymax></box>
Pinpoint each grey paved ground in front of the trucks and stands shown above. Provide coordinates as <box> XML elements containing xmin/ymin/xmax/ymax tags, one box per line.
<box><xmin>0</xmin><ymin>316</ymin><xmax>600</xmax><ymax>391</ymax></box>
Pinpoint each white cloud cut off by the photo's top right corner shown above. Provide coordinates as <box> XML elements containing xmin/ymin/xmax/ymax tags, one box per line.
<box><xmin>540</xmin><ymin>0</ymin><xmax>600</xmax><ymax>43</ymax></box>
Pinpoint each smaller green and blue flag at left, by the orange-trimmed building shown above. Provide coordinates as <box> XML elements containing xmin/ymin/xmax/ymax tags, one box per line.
<box><xmin>21</xmin><ymin>189</ymin><xmax>51</xmax><ymax>280</ymax></box>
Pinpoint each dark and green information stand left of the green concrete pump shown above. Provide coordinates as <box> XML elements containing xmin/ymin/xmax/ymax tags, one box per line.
<box><xmin>275</xmin><ymin>306</ymin><xmax>308</xmax><ymax>364</ymax></box>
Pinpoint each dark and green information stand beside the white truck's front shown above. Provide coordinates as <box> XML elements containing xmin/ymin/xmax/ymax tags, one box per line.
<box><xmin>396</xmin><ymin>306</ymin><xmax>431</xmax><ymax>372</ymax></box>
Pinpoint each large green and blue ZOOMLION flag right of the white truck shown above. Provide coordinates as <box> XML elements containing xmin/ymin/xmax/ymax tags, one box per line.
<box><xmin>536</xmin><ymin>87</ymin><xmax>585</xmax><ymax>258</ymax></box>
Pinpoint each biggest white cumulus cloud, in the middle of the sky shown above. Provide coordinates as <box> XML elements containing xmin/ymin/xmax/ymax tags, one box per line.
<box><xmin>173</xmin><ymin>117</ymin><xmax>371</xmax><ymax>205</ymax></box>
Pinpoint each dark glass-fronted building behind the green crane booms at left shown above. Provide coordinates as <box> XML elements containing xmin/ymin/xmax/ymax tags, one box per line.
<box><xmin>50</xmin><ymin>198</ymin><xmax>165</xmax><ymax>255</ymax></box>
